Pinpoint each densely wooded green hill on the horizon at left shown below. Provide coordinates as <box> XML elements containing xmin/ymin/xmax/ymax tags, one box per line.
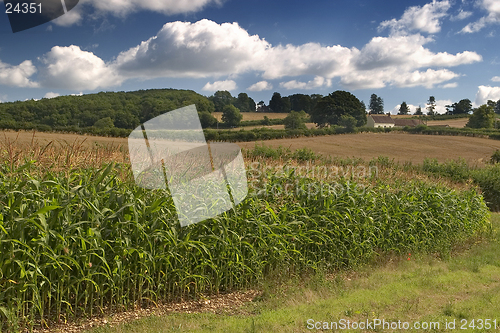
<box><xmin>0</xmin><ymin>89</ymin><xmax>215</xmax><ymax>131</ymax></box>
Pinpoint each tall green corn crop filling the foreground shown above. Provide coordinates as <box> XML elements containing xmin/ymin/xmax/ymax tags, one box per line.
<box><xmin>0</xmin><ymin>158</ymin><xmax>489</xmax><ymax>331</ymax></box>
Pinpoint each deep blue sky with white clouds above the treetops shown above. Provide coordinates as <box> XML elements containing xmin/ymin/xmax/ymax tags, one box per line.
<box><xmin>0</xmin><ymin>0</ymin><xmax>500</xmax><ymax>112</ymax></box>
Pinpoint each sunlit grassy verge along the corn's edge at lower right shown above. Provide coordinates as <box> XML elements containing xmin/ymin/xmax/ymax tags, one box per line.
<box><xmin>88</xmin><ymin>214</ymin><xmax>500</xmax><ymax>333</ymax></box>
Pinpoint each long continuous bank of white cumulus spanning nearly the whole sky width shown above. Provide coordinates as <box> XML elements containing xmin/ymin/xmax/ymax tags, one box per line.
<box><xmin>6</xmin><ymin>16</ymin><xmax>482</xmax><ymax>91</ymax></box>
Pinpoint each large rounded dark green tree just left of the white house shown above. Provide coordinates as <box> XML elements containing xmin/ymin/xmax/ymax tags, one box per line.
<box><xmin>311</xmin><ymin>90</ymin><xmax>366</xmax><ymax>127</ymax></box>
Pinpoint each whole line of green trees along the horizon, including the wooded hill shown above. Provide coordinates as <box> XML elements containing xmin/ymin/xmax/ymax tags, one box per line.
<box><xmin>0</xmin><ymin>89</ymin><xmax>500</xmax><ymax>136</ymax></box>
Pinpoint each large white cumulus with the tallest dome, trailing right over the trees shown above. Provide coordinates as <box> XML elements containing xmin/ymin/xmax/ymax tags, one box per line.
<box><xmin>114</xmin><ymin>19</ymin><xmax>482</xmax><ymax>89</ymax></box>
